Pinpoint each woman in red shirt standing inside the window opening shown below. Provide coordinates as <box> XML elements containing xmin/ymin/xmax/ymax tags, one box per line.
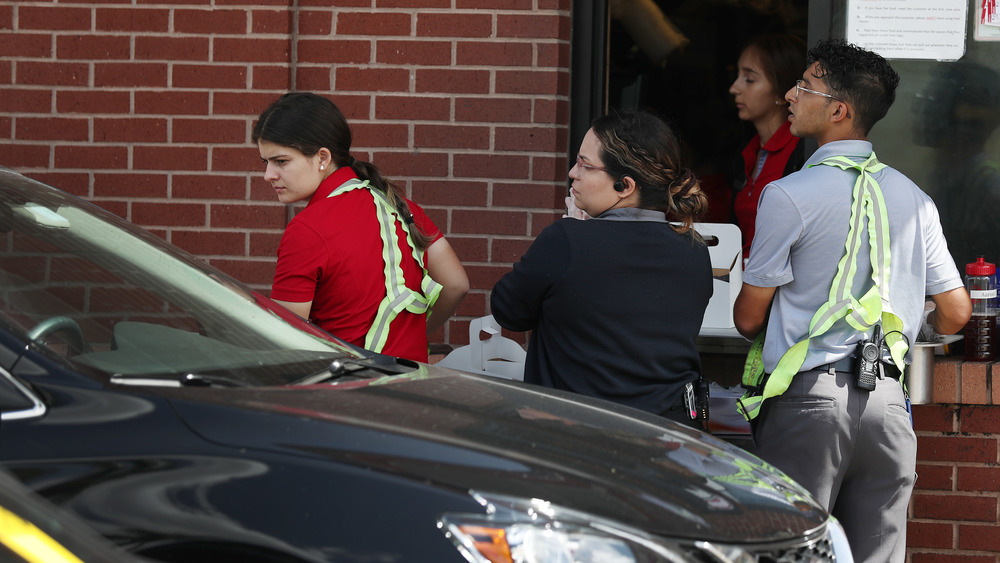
<box><xmin>729</xmin><ymin>35</ymin><xmax>806</xmax><ymax>260</ymax></box>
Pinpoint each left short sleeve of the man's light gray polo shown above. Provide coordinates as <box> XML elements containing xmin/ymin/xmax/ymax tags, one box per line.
<box><xmin>743</xmin><ymin>184</ymin><xmax>803</xmax><ymax>287</ymax></box>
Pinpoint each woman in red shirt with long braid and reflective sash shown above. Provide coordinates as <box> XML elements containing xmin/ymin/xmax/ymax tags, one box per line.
<box><xmin>252</xmin><ymin>92</ymin><xmax>469</xmax><ymax>362</ymax></box>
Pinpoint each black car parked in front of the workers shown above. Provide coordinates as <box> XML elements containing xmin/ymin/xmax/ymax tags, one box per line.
<box><xmin>0</xmin><ymin>169</ymin><xmax>850</xmax><ymax>563</ymax></box>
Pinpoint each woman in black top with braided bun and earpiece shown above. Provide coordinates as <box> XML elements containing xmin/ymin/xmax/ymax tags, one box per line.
<box><xmin>490</xmin><ymin>112</ymin><xmax>712</xmax><ymax>426</ymax></box>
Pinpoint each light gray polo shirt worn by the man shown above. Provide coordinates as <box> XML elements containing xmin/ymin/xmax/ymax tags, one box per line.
<box><xmin>743</xmin><ymin>141</ymin><xmax>963</xmax><ymax>373</ymax></box>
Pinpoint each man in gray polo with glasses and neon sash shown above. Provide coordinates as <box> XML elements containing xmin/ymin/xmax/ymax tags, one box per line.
<box><xmin>734</xmin><ymin>37</ymin><xmax>971</xmax><ymax>563</ymax></box>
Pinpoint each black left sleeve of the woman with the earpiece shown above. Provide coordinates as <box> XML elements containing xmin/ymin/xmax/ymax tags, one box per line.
<box><xmin>490</xmin><ymin>223</ymin><xmax>579</xmax><ymax>332</ymax></box>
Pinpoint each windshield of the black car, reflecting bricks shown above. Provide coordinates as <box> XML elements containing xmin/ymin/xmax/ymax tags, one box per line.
<box><xmin>0</xmin><ymin>168</ymin><xmax>361</xmax><ymax>385</ymax></box>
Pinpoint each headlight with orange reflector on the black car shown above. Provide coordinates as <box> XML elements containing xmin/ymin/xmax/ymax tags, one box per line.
<box><xmin>438</xmin><ymin>492</ymin><xmax>751</xmax><ymax>563</ymax></box>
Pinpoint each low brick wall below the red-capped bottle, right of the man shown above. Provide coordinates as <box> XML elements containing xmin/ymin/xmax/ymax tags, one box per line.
<box><xmin>907</xmin><ymin>358</ymin><xmax>1000</xmax><ymax>563</ymax></box>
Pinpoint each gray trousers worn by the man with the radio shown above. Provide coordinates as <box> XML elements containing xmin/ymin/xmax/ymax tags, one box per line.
<box><xmin>754</xmin><ymin>370</ymin><xmax>917</xmax><ymax>563</ymax></box>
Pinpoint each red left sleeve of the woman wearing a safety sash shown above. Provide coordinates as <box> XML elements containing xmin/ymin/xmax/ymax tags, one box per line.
<box><xmin>271</xmin><ymin>221</ymin><xmax>328</xmax><ymax>303</ymax></box>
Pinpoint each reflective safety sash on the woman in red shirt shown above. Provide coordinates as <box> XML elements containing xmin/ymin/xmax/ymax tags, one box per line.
<box><xmin>327</xmin><ymin>179</ymin><xmax>441</xmax><ymax>352</ymax></box>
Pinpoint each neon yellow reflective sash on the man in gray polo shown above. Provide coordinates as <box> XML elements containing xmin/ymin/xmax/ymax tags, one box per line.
<box><xmin>737</xmin><ymin>152</ymin><xmax>908</xmax><ymax>420</ymax></box>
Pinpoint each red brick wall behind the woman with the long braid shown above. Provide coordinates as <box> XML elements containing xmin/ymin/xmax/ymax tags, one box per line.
<box><xmin>0</xmin><ymin>0</ymin><xmax>570</xmax><ymax>345</ymax></box>
